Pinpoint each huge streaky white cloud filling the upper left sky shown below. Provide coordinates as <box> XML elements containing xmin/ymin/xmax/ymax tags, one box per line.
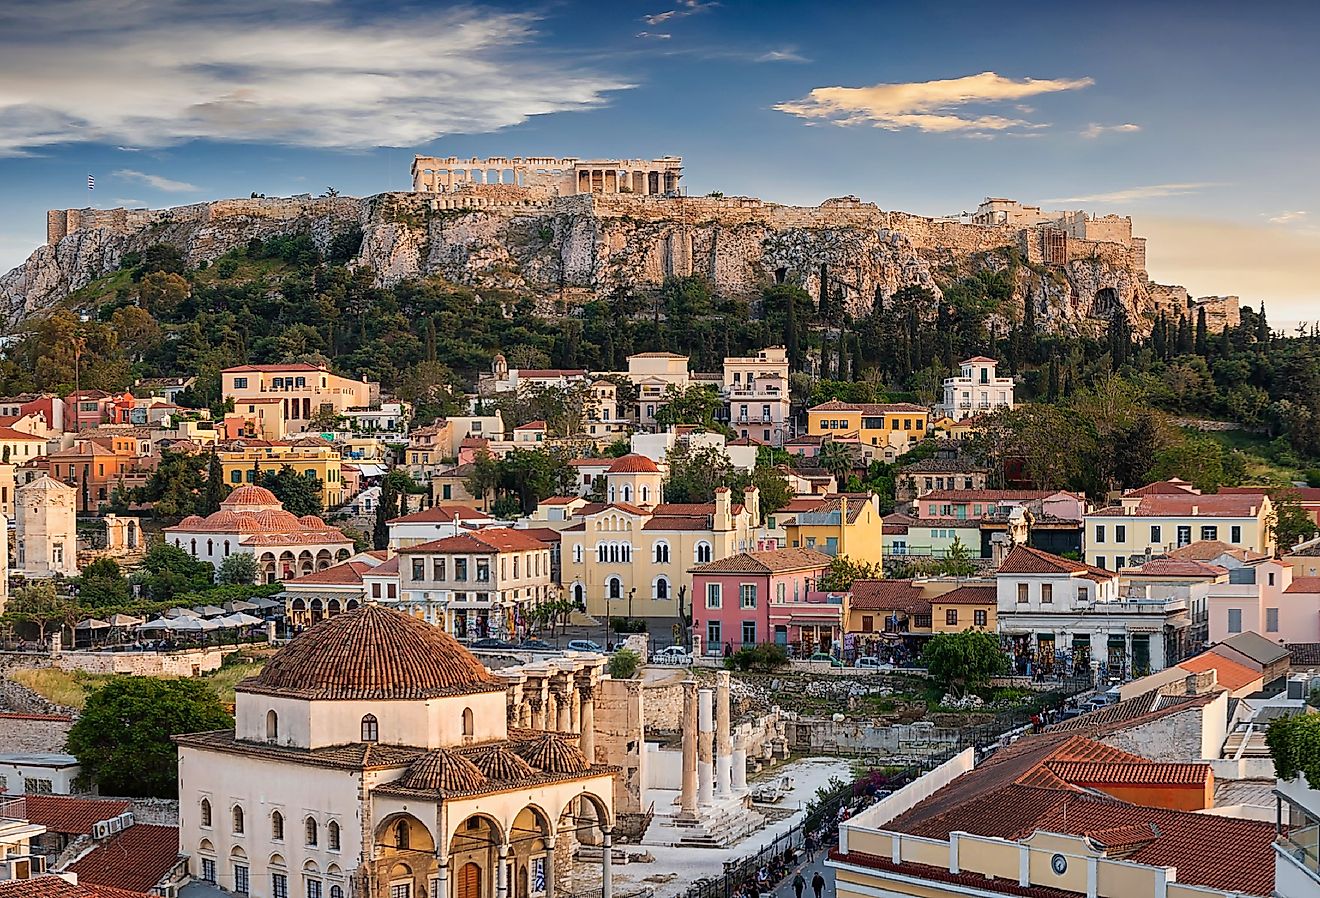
<box><xmin>0</xmin><ymin>0</ymin><xmax>631</xmax><ymax>156</ymax></box>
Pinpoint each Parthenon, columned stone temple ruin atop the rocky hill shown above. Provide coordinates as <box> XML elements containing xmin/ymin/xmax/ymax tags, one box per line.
<box><xmin>412</xmin><ymin>156</ymin><xmax>682</xmax><ymax>197</ymax></box>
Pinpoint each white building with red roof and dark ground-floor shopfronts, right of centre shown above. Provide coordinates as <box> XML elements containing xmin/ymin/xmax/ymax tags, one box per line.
<box><xmin>995</xmin><ymin>545</ymin><xmax>1192</xmax><ymax>679</ymax></box>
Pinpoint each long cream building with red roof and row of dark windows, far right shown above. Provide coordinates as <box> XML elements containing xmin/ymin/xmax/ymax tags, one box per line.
<box><xmin>1084</xmin><ymin>490</ymin><xmax>1275</xmax><ymax>570</ymax></box>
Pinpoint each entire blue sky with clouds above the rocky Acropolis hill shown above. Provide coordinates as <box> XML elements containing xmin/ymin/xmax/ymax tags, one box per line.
<box><xmin>0</xmin><ymin>0</ymin><xmax>1320</xmax><ymax>322</ymax></box>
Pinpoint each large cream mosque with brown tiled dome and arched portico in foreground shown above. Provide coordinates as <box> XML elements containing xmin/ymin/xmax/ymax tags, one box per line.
<box><xmin>176</xmin><ymin>605</ymin><xmax>620</xmax><ymax>898</ymax></box>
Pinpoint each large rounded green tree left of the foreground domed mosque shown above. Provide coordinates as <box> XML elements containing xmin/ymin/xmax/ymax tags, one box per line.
<box><xmin>69</xmin><ymin>676</ymin><xmax>234</xmax><ymax>798</ymax></box>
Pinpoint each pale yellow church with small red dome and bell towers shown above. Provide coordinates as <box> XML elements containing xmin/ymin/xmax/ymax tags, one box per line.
<box><xmin>560</xmin><ymin>456</ymin><xmax>760</xmax><ymax>619</ymax></box>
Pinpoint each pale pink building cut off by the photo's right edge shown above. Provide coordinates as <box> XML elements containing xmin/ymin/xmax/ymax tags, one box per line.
<box><xmin>1206</xmin><ymin>559</ymin><xmax>1320</xmax><ymax>644</ymax></box>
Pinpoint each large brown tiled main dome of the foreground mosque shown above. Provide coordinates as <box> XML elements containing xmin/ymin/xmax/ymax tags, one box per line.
<box><xmin>238</xmin><ymin>605</ymin><xmax>504</xmax><ymax>699</ymax></box>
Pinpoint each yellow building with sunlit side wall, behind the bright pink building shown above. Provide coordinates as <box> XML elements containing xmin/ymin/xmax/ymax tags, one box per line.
<box><xmin>776</xmin><ymin>493</ymin><xmax>884</xmax><ymax>570</ymax></box>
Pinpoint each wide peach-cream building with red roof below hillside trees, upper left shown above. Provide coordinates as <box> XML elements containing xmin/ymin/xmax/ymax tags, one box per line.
<box><xmin>220</xmin><ymin>362</ymin><xmax>380</xmax><ymax>436</ymax></box>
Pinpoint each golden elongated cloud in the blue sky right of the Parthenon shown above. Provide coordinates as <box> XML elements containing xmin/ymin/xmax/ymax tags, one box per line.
<box><xmin>775</xmin><ymin>71</ymin><xmax>1094</xmax><ymax>133</ymax></box>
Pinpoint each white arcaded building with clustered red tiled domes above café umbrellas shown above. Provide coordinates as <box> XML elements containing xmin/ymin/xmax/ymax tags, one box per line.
<box><xmin>165</xmin><ymin>485</ymin><xmax>354</xmax><ymax>584</ymax></box>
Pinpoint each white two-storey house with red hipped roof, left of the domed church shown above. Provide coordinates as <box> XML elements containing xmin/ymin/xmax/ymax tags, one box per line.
<box><xmin>396</xmin><ymin>527</ymin><xmax>552</xmax><ymax>639</ymax></box>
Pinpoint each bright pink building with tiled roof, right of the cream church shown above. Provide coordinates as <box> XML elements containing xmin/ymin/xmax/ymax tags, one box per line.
<box><xmin>692</xmin><ymin>549</ymin><xmax>823</xmax><ymax>655</ymax></box>
